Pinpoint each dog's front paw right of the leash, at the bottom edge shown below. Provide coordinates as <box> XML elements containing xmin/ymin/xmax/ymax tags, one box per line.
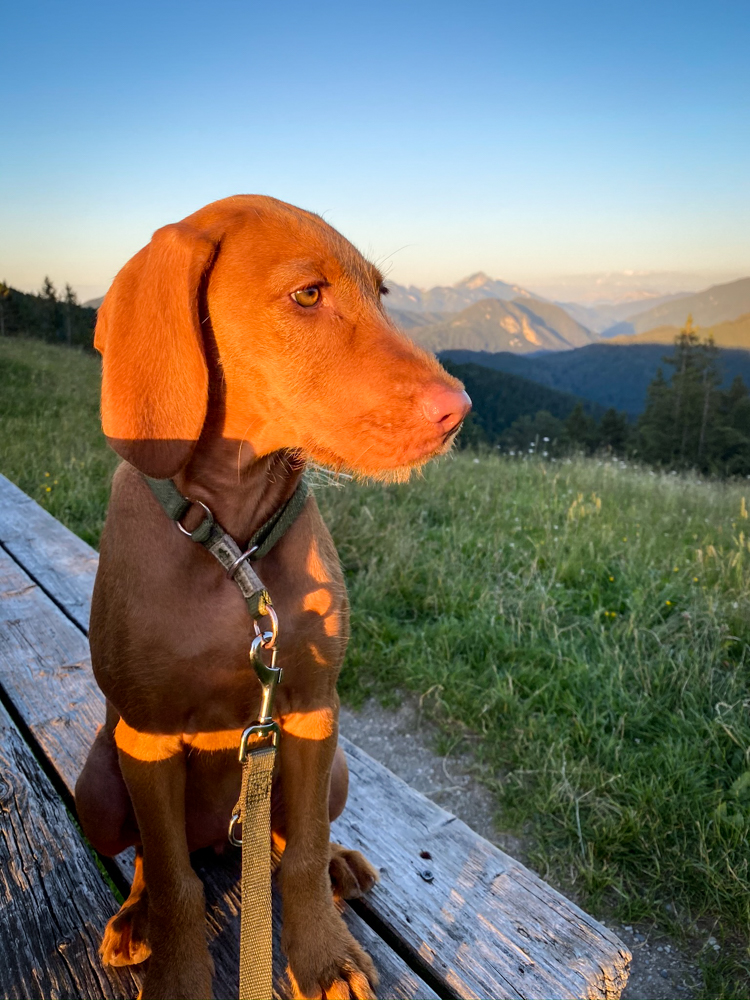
<box><xmin>284</xmin><ymin>910</ymin><xmax>378</xmax><ymax>1000</ymax></box>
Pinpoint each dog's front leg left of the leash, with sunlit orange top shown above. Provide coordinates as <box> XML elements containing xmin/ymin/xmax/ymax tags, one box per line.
<box><xmin>115</xmin><ymin>719</ymin><xmax>213</xmax><ymax>1000</ymax></box>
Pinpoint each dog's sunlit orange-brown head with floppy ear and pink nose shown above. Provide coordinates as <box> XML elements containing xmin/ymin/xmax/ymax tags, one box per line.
<box><xmin>95</xmin><ymin>195</ymin><xmax>471</xmax><ymax>478</ymax></box>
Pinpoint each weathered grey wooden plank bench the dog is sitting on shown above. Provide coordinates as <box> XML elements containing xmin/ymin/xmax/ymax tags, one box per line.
<box><xmin>0</xmin><ymin>476</ymin><xmax>630</xmax><ymax>1000</ymax></box>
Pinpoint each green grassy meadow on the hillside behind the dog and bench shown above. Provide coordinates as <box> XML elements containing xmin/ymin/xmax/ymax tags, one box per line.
<box><xmin>0</xmin><ymin>340</ymin><xmax>750</xmax><ymax>997</ymax></box>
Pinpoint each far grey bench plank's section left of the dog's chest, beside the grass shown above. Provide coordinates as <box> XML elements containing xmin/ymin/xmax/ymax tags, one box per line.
<box><xmin>0</xmin><ymin>475</ymin><xmax>99</xmax><ymax>631</ymax></box>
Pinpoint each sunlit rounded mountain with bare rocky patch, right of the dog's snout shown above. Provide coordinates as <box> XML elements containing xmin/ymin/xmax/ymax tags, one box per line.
<box><xmin>409</xmin><ymin>298</ymin><xmax>595</xmax><ymax>354</ymax></box>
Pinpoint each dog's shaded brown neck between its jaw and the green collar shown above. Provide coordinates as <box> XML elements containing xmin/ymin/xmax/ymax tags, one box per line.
<box><xmin>174</xmin><ymin>421</ymin><xmax>305</xmax><ymax>547</ymax></box>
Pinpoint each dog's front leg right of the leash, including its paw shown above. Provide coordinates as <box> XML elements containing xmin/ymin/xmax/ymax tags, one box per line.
<box><xmin>279</xmin><ymin>710</ymin><xmax>377</xmax><ymax>1000</ymax></box>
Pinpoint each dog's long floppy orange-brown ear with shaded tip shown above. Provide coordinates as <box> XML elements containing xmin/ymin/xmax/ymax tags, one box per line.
<box><xmin>94</xmin><ymin>222</ymin><xmax>218</xmax><ymax>479</ymax></box>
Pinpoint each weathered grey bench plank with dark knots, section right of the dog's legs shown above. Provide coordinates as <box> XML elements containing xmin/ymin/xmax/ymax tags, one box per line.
<box><xmin>333</xmin><ymin>739</ymin><xmax>630</xmax><ymax>998</ymax></box>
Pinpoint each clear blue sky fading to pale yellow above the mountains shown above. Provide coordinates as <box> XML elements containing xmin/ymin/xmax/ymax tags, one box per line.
<box><xmin>0</xmin><ymin>0</ymin><xmax>750</xmax><ymax>298</ymax></box>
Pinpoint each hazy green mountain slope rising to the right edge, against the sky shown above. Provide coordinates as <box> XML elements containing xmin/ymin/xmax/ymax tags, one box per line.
<box><xmin>603</xmin><ymin>278</ymin><xmax>750</xmax><ymax>337</ymax></box>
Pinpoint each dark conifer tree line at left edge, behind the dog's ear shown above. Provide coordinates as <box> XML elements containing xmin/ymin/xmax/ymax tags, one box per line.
<box><xmin>0</xmin><ymin>277</ymin><xmax>96</xmax><ymax>350</ymax></box>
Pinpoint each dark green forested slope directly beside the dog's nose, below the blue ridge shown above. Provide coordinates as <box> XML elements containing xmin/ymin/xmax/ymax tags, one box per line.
<box><xmin>444</xmin><ymin>359</ymin><xmax>604</xmax><ymax>441</ymax></box>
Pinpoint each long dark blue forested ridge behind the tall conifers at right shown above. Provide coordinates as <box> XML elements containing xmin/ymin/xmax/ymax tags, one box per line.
<box><xmin>440</xmin><ymin>341</ymin><xmax>750</xmax><ymax>417</ymax></box>
